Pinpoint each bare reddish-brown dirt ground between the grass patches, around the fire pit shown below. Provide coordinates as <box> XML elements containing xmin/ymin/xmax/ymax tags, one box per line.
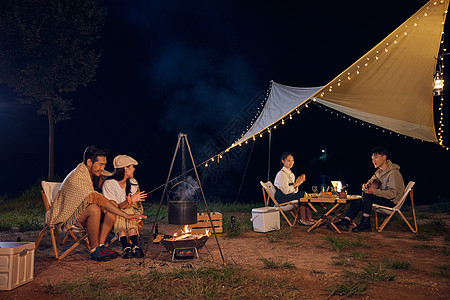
<box><xmin>0</xmin><ymin>214</ymin><xmax>450</xmax><ymax>299</ymax></box>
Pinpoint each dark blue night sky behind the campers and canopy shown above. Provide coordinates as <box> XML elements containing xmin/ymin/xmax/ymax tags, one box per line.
<box><xmin>0</xmin><ymin>0</ymin><xmax>450</xmax><ymax>203</ymax></box>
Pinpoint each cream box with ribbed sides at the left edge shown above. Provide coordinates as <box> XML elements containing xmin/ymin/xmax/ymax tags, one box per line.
<box><xmin>0</xmin><ymin>242</ymin><xmax>34</xmax><ymax>290</ymax></box>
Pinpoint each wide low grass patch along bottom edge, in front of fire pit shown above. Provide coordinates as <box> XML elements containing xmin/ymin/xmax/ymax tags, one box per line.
<box><xmin>46</xmin><ymin>264</ymin><xmax>302</xmax><ymax>299</ymax></box>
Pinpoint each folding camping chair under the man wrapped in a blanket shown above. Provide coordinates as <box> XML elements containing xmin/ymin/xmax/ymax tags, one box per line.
<box><xmin>35</xmin><ymin>181</ymin><xmax>89</xmax><ymax>260</ymax></box>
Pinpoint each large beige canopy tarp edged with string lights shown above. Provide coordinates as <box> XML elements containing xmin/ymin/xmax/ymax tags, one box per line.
<box><xmin>233</xmin><ymin>0</ymin><xmax>449</xmax><ymax>146</ymax></box>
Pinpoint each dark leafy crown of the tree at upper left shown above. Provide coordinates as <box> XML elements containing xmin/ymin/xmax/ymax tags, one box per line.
<box><xmin>0</xmin><ymin>0</ymin><xmax>106</xmax><ymax>122</ymax></box>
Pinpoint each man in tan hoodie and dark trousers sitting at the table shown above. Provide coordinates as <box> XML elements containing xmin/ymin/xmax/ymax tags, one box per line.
<box><xmin>335</xmin><ymin>147</ymin><xmax>405</xmax><ymax>232</ymax></box>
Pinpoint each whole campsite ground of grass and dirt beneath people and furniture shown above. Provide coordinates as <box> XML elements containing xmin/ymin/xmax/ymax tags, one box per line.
<box><xmin>0</xmin><ymin>186</ymin><xmax>450</xmax><ymax>299</ymax></box>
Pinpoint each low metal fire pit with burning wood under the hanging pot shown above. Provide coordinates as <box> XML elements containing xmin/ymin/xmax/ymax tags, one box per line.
<box><xmin>161</xmin><ymin>226</ymin><xmax>209</xmax><ymax>260</ymax></box>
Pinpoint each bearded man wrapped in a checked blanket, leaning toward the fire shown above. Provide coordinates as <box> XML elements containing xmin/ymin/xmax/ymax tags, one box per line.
<box><xmin>50</xmin><ymin>146</ymin><xmax>147</xmax><ymax>261</ymax></box>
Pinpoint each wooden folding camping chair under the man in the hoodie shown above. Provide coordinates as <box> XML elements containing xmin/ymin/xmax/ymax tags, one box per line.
<box><xmin>372</xmin><ymin>181</ymin><xmax>417</xmax><ymax>233</ymax></box>
